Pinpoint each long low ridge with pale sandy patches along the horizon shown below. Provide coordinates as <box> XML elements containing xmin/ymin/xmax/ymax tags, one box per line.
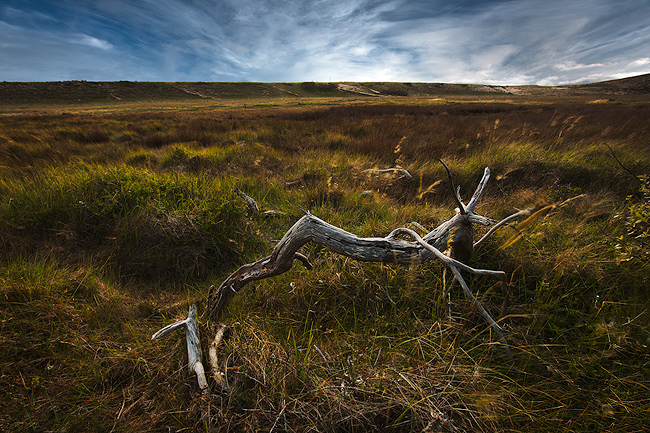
<box><xmin>0</xmin><ymin>74</ymin><xmax>650</xmax><ymax>106</ymax></box>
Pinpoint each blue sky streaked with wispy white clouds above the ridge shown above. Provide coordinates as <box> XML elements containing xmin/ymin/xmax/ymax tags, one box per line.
<box><xmin>0</xmin><ymin>0</ymin><xmax>650</xmax><ymax>85</ymax></box>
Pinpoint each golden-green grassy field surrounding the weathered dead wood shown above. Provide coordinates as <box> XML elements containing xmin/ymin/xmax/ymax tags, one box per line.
<box><xmin>0</xmin><ymin>92</ymin><xmax>650</xmax><ymax>432</ymax></box>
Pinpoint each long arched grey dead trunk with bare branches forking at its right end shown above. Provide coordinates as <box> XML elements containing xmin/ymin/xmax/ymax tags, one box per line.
<box><xmin>206</xmin><ymin>161</ymin><xmax>522</xmax><ymax>356</ymax></box>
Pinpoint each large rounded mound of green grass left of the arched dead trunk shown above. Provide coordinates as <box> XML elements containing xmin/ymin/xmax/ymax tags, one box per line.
<box><xmin>2</xmin><ymin>163</ymin><xmax>258</xmax><ymax>281</ymax></box>
